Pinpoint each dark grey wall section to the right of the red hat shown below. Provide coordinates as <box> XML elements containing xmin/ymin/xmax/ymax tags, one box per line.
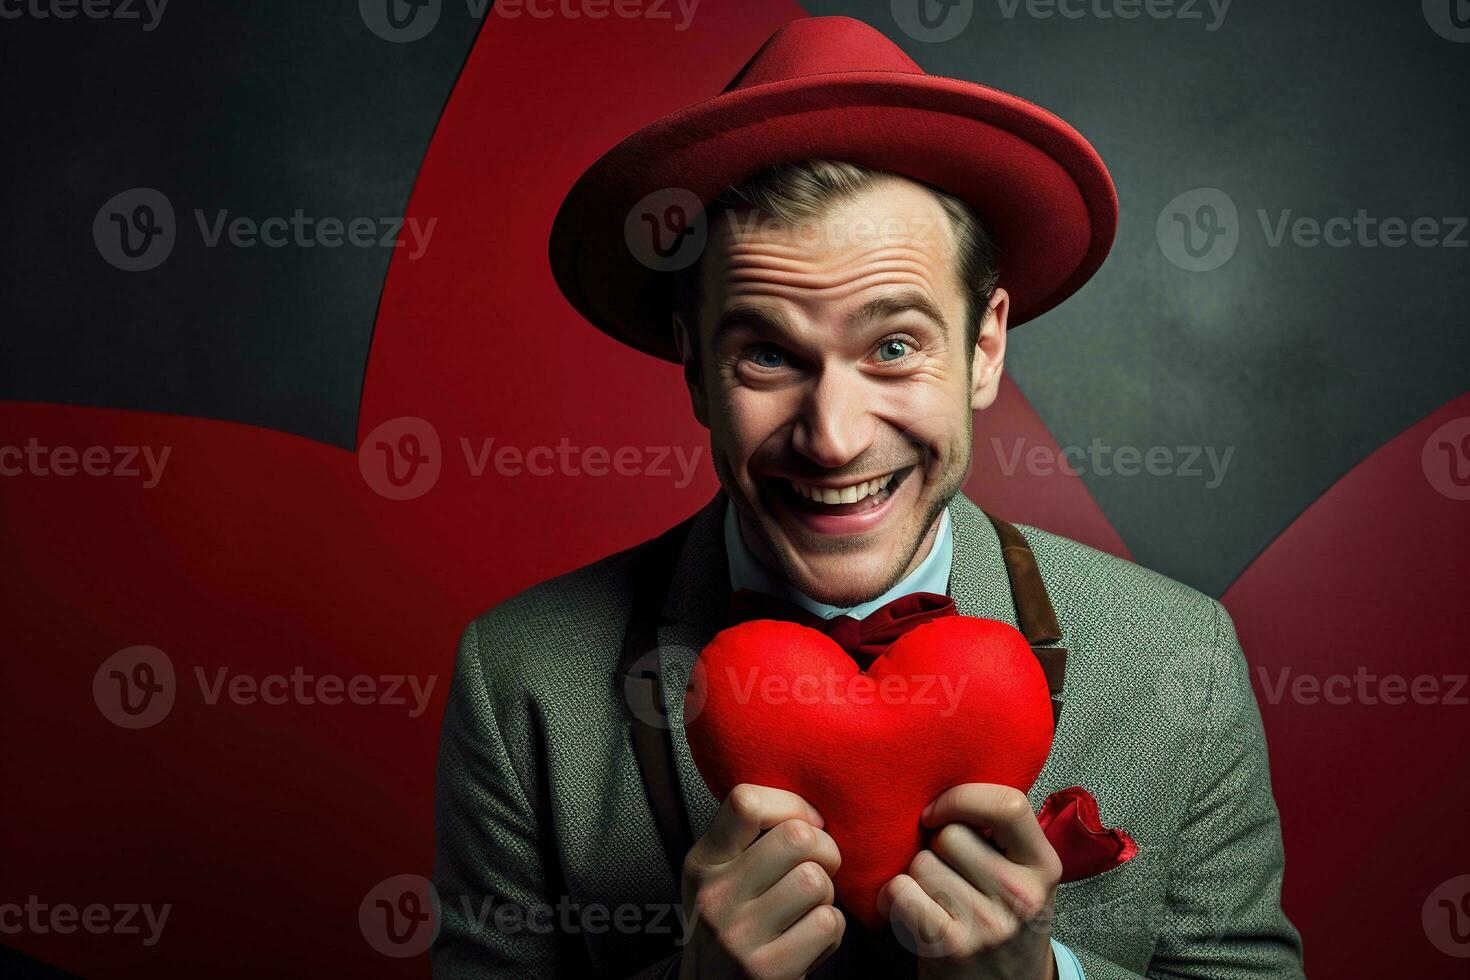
<box><xmin>806</xmin><ymin>0</ymin><xmax>1470</xmax><ymax>595</ymax></box>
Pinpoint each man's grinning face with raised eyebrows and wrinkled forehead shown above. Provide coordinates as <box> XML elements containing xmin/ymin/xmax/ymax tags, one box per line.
<box><xmin>682</xmin><ymin>178</ymin><xmax>1007</xmax><ymax>607</ymax></box>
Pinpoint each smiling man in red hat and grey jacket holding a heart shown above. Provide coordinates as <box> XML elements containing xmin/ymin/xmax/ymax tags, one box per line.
<box><xmin>434</xmin><ymin>18</ymin><xmax>1301</xmax><ymax>980</ymax></box>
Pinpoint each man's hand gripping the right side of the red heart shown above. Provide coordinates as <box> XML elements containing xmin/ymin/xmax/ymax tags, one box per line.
<box><xmin>878</xmin><ymin>783</ymin><xmax>1061</xmax><ymax>980</ymax></box>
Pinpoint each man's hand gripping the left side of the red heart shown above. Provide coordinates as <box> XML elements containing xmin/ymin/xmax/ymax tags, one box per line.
<box><xmin>679</xmin><ymin>783</ymin><xmax>847</xmax><ymax>980</ymax></box>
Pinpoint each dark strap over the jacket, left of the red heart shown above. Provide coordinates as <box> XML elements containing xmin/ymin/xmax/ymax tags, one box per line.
<box><xmin>619</xmin><ymin>517</ymin><xmax>694</xmax><ymax>884</ymax></box>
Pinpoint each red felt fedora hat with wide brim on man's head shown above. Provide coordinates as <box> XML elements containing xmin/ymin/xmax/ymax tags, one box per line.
<box><xmin>550</xmin><ymin>16</ymin><xmax>1117</xmax><ymax>361</ymax></box>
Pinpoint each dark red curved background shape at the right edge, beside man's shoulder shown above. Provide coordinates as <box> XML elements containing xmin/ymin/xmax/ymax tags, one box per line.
<box><xmin>1223</xmin><ymin>395</ymin><xmax>1470</xmax><ymax>977</ymax></box>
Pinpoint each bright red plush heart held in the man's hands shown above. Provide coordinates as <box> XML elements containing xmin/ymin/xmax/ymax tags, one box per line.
<box><xmin>685</xmin><ymin>616</ymin><xmax>1053</xmax><ymax>929</ymax></box>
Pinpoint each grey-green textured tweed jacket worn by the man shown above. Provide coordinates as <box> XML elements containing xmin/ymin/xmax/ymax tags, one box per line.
<box><xmin>432</xmin><ymin>494</ymin><xmax>1301</xmax><ymax>980</ymax></box>
